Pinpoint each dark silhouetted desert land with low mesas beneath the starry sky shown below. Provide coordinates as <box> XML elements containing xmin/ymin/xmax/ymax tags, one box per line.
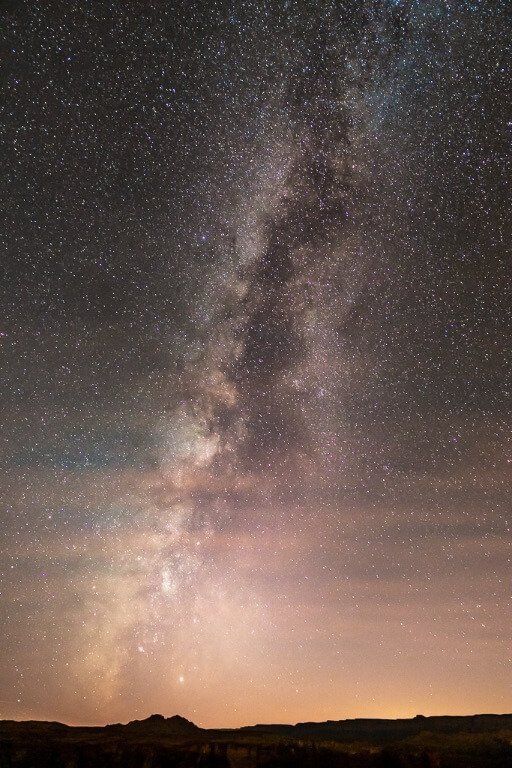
<box><xmin>0</xmin><ymin>715</ymin><xmax>512</xmax><ymax>768</ymax></box>
